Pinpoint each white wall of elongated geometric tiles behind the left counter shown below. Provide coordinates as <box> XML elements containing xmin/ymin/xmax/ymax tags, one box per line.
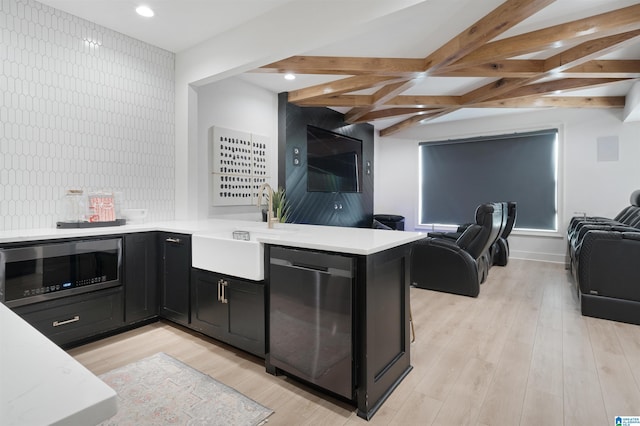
<box><xmin>0</xmin><ymin>0</ymin><xmax>175</xmax><ymax>231</ymax></box>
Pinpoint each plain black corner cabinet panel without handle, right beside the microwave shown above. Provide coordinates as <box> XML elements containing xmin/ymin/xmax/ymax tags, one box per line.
<box><xmin>124</xmin><ymin>232</ymin><xmax>158</xmax><ymax>324</ymax></box>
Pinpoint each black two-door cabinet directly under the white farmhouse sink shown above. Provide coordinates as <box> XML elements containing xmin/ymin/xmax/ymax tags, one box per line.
<box><xmin>190</xmin><ymin>268</ymin><xmax>265</xmax><ymax>357</ymax></box>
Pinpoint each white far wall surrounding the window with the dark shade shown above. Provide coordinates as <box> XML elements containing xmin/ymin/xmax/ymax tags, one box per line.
<box><xmin>374</xmin><ymin>109</ymin><xmax>640</xmax><ymax>262</ymax></box>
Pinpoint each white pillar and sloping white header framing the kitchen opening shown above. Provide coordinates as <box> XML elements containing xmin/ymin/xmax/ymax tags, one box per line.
<box><xmin>175</xmin><ymin>0</ymin><xmax>425</xmax><ymax>219</ymax></box>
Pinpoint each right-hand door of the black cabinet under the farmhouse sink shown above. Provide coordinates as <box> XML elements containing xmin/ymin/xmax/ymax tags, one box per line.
<box><xmin>224</xmin><ymin>278</ymin><xmax>265</xmax><ymax>357</ymax></box>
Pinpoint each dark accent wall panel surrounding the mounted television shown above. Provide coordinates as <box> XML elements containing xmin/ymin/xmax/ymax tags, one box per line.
<box><xmin>278</xmin><ymin>93</ymin><xmax>373</xmax><ymax>228</ymax></box>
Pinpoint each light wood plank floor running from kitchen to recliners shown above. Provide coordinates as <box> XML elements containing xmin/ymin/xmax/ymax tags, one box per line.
<box><xmin>69</xmin><ymin>259</ymin><xmax>640</xmax><ymax>426</ymax></box>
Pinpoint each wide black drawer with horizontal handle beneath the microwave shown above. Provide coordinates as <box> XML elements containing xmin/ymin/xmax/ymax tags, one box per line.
<box><xmin>15</xmin><ymin>288</ymin><xmax>124</xmax><ymax>345</ymax></box>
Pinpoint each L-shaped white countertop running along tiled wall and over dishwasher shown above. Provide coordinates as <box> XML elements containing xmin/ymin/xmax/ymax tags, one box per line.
<box><xmin>0</xmin><ymin>219</ymin><xmax>426</xmax><ymax>255</ymax></box>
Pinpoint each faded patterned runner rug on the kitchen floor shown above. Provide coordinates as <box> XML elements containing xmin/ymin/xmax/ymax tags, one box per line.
<box><xmin>100</xmin><ymin>352</ymin><xmax>273</xmax><ymax>426</ymax></box>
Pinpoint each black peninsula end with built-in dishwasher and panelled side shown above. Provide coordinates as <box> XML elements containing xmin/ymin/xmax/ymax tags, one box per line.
<box><xmin>266</xmin><ymin>245</ymin><xmax>411</xmax><ymax>419</ymax></box>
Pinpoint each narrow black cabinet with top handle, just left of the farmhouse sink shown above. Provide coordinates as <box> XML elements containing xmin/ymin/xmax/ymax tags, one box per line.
<box><xmin>160</xmin><ymin>233</ymin><xmax>191</xmax><ymax>325</ymax></box>
